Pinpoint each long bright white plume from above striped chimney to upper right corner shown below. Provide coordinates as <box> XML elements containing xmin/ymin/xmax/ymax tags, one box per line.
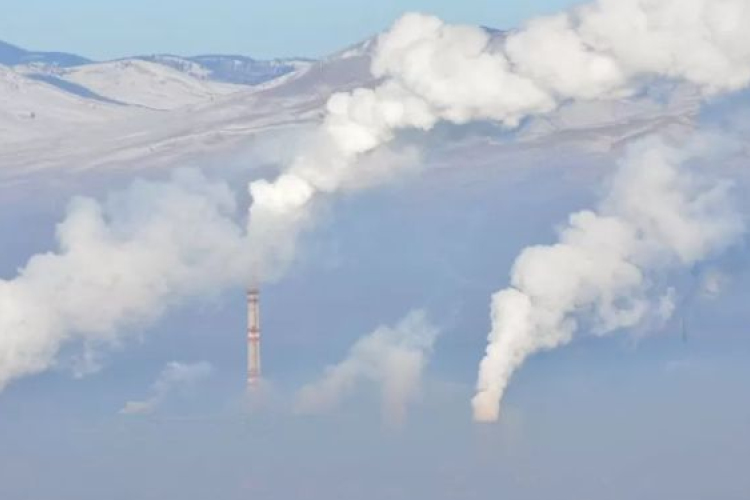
<box><xmin>245</xmin><ymin>0</ymin><xmax>750</xmax><ymax>284</ymax></box>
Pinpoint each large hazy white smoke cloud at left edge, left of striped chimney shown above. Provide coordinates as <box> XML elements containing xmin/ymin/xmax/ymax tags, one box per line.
<box><xmin>0</xmin><ymin>171</ymin><xmax>250</xmax><ymax>388</ymax></box>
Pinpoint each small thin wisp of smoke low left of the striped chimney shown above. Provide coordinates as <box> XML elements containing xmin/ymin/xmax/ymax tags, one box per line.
<box><xmin>119</xmin><ymin>361</ymin><xmax>213</xmax><ymax>415</ymax></box>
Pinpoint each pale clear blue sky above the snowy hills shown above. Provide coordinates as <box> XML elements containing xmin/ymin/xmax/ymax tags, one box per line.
<box><xmin>0</xmin><ymin>0</ymin><xmax>577</xmax><ymax>59</ymax></box>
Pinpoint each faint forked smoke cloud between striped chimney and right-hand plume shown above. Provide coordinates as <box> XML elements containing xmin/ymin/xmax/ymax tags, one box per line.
<box><xmin>297</xmin><ymin>311</ymin><xmax>438</xmax><ymax>425</ymax></box>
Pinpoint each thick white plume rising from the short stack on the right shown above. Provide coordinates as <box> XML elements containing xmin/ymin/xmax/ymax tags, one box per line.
<box><xmin>472</xmin><ymin>141</ymin><xmax>744</xmax><ymax>421</ymax></box>
